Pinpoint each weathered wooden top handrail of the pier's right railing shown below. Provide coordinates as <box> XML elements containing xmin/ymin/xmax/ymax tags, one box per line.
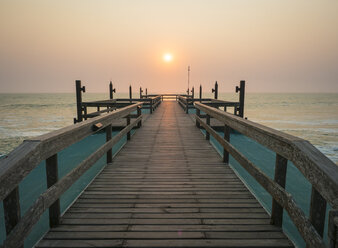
<box><xmin>195</xmin><ymin>102</ymin><xmax>338</xmax><ymax>208</ymax></box>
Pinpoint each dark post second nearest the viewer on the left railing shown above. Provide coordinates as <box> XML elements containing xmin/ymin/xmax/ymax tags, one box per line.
<box><xmin>46</xmin><ymin>153</ymin><xmax>60</xmax><ymax>227</ymax></box>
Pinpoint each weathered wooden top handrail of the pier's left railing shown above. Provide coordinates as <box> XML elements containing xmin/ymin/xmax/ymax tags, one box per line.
<box><xmin>0</xmin><ymin>102</ymin><xmax>143</xmax><ymax>201</ymax></box>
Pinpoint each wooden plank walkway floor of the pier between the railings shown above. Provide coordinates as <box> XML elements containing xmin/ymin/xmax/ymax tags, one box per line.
<box><xmin>37</xmin><ymin>102</ymin><xmax>293</xmax><ymax>247</ymax></box>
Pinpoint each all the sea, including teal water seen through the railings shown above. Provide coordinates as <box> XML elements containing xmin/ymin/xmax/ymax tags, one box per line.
<box><xmin>0</xmin><ymin>93</ymin><xmax>338</xmax><ymax>248</ymax></box>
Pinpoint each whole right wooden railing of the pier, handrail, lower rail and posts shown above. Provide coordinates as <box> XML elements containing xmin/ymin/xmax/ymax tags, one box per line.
<box><xmin>194</xmin><ymin>101</ymin><xmax>338</xmax><ymax>248</ymax></box>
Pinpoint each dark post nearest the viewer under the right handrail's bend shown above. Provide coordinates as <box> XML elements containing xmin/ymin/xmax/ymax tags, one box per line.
<box><xmin>309</xmin><ymin>186</ymin><xmax>326</xmax><ymax>237</ymax></box>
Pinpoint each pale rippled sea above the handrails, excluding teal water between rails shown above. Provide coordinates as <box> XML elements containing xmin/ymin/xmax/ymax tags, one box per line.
<box><xmin>0</xmin><ymin>93</ymin><xmax>338</xmax><ymax>164</ymax></box>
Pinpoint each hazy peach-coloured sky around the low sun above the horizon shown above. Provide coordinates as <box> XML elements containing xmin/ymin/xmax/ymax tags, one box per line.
<box><xmin>0</xmin><ymin>0</ymin><xmax>338</xmax><ymax>93</ymax></box>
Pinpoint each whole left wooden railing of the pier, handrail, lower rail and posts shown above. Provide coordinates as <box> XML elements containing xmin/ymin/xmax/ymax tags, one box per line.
<box><xmin>0</xmin><ymin>103</ymin><xmax>143</xmax><ymax>247</ymax></box>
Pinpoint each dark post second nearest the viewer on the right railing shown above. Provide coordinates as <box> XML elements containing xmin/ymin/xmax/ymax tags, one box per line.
<box><xmin>270</xmin><ymin>154</ymin><xmax>288</xmax><ymax>227</ymax></box>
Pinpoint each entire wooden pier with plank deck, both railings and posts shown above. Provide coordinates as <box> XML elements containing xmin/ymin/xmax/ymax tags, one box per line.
<box><xmin>0</xmin><ymin>81</ymin><xmax>338</xmax><ymax>248</ymax></box>
